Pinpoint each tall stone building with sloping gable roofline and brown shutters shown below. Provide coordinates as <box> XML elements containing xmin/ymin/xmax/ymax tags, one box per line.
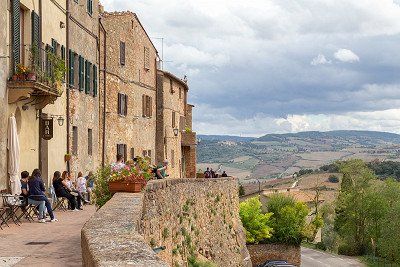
<box><xmin>100</xmin><ymin>12</ymin><xmax>158</xmax><ymax>164</ymax></box>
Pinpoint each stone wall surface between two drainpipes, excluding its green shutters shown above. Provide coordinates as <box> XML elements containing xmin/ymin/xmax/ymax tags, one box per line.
<box><xmin>67</xmin><ymin>0</ymin><xmax>100</xmax><ymax>177</ymax></box>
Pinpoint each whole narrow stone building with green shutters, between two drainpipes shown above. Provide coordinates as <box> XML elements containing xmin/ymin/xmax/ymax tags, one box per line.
<box><xmin>67</xmin><ymin>0</ymin><xmax>100</xmax><ymax>177</ymax></box>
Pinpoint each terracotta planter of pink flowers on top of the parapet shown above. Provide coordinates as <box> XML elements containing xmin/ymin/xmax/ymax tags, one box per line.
<box><xmin>108</xmin><ymin>158</ymin><xmax>152</xmax><ymax>193</ymax></box>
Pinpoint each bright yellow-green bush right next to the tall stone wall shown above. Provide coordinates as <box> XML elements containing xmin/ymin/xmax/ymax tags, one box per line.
<box><xmin>239</xmin><ymin>197</ymin><xmax>273</xmax><ymax>244</ymax></box>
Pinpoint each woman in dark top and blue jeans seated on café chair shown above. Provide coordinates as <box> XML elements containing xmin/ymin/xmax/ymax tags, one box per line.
<box><xmin>28</xmin><ymin>169</ymin><xmax>58</xmax><ymax>222</ymax></box>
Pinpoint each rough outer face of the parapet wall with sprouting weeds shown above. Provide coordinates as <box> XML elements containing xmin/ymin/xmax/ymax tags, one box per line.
<box><xmin>140</xmin><ymin>178</ymin><xmax>251</xmax><ymax>266</ymax></box>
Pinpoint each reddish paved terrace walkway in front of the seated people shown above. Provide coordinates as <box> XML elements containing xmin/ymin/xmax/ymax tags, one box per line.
<box><xmin>0</xmin><ymin>205</ymin><xmax>95</xmax><ymax>267</ymax></box>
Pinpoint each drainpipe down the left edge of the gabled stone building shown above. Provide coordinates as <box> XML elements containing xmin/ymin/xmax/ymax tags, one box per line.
<box><xmin>99</xmin><ymin>18</ymin><xmax>107</xmax><ymax>167</ymax></box>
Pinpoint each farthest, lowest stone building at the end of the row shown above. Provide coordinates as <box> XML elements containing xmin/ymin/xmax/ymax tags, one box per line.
<box><xmin>156</xmin><ymin>70</ymin><xmax>196</xmax><ymax>178</ymax></box>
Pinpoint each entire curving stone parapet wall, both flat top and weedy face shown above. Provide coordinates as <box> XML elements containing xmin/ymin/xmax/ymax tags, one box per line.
<box><xmin>82</xmin><ymin>178</ymin><xmax>251</xmax><ymax>266</ymax></box>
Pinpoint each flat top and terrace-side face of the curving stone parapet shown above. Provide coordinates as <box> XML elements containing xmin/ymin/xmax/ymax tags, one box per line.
<box><xmin>81</xmin><ymin>193</ymin><xmax>168</xmax><ymax>267</ymax></box>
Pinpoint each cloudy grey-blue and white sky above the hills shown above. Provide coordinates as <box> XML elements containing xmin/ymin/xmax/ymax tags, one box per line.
<box><xmin>102</xmin><ymin>0</ymin><xmax>400</xmax><ymax>136</ymax></box>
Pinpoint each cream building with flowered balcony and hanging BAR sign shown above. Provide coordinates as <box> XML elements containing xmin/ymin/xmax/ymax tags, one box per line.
<box><xmin>0</xmin><ymin>0</ymin><xmax>67</xmax><ymax>189</ymax></box>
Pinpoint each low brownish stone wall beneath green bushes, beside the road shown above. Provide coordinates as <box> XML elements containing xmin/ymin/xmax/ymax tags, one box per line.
<box><xmin>247</xmin><ymin>244</ymin><xmax>301</xmax><ymax>266</ymax></box>
